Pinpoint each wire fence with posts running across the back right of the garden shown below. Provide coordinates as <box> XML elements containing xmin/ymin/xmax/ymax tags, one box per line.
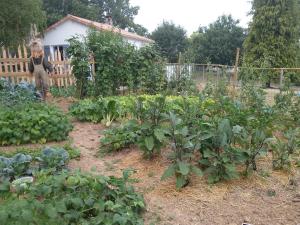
<box><xmin>166</xmin><ymin>64</ymin><xmax>300</xmax><ymax>90</ymax></box>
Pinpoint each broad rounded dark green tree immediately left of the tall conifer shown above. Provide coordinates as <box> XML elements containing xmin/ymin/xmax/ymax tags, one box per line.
<box><xmin>189</xmin><ymin>15</ymin><xmax>245</xmax><ymax>65</ymax></box>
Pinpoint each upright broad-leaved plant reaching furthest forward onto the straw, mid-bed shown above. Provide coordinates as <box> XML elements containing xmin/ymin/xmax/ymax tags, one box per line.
<box><xmin>161</xmin><ymin>112</ymin><xmax>202</xmax><ymax>189</ymax></box>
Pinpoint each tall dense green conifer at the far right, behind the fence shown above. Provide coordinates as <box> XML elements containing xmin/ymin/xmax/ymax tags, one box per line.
<box><xmin>244</xmin><ymin>0</ymin><xmax>299</xmax><ymax>86</ymax></box>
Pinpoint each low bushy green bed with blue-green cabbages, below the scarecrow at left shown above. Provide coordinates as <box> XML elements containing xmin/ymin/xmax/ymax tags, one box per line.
<box><xmin>0</xmin><ymin>80</ymin><xmax>72</xmax><ymax>146</ymax></box>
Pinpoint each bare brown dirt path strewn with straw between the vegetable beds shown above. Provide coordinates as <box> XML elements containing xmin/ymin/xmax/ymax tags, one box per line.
<box><xmin>66</xmin><ymin>122</ymin><xmax>300</xmax><ymax>225</ymax></box>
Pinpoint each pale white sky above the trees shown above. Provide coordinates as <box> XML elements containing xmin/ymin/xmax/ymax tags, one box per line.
<box><xmin>130</xmin><ymin>0</ymin><xmax>251</xmax><ymax>35</ymax></box>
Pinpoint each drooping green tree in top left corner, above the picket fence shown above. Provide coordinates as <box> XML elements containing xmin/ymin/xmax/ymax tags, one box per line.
<box><xmin>0</xmin><ymin>0</ymin><xmax>46</xmax><ymax>47</ymax></box>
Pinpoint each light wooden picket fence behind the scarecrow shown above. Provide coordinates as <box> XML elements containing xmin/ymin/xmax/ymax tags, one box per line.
<box><xmin>0</xmin><ymin>46</ymin><xmax>75</xmax><ymax>87</ymax></box>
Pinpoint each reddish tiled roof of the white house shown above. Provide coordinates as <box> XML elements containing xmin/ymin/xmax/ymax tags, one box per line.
<box><xmin>45</xmin><ymin>14</ymin><xmax>154</xmax><ymax>43</ymax></box>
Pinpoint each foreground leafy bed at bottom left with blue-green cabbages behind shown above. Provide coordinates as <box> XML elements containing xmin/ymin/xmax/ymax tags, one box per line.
<box><xmin>0</xmin><ymin>147</ymin><xmax>145</xmax><ymax>225</ymax></box>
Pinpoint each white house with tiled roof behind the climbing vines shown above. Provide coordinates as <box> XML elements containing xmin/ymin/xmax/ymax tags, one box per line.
<box><xmin>42</xmin><ymin>15</ymin><xmax>154</xmax><ymax>57</ymax></box>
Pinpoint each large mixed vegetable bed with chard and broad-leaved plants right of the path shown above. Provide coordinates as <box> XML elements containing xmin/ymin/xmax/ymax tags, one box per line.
<box><xmin>71</xmin><ymin>82</ymin><xmax>300</xmax><ymax>188</ymax></box>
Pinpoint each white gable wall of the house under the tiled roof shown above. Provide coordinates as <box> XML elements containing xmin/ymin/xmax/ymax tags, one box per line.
<box><xmin>43</xmin><ymin>20</ymin><xmax>88</xmax><ymax>46</ymax></box>
